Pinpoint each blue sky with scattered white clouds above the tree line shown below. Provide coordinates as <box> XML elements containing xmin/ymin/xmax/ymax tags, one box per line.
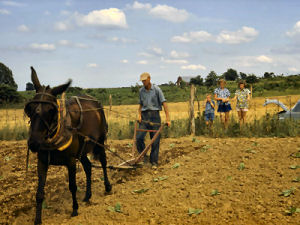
<box><xmin>0</xmin><ymin>0</ymin><xmax>300</xmax><ymax>90</ymax></box>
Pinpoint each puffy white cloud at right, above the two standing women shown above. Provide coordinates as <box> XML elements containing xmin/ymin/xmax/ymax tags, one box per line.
<box><xmin>216</xmin><ymin>26</ymin><xmax>258</xmax><ymax>44</ymax></box>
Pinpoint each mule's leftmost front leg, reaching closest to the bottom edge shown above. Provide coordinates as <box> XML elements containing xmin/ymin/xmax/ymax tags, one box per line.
<box><xmin>34</xmin><ymin>157</ymin><xmax>48</xmax><ymax>224</ymax></box>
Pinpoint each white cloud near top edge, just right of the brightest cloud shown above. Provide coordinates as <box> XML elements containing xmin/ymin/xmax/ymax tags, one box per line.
<box><xmin>149</xmin><ymin>5</ymin><xmax>189</xmax><ymax>23</ymax></box>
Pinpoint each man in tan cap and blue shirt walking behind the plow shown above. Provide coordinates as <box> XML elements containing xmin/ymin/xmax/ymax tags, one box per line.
<box><xmin>136</xmin><ymin>73</ymin><xmax>171</xmax><ymax>169</ymax></box>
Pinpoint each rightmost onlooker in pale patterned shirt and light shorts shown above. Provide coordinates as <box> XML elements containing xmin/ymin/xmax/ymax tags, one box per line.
<box><xmin>233</xmin><ymin>80</ymin><xmax>250</xmax><ymax>127</ymax></box>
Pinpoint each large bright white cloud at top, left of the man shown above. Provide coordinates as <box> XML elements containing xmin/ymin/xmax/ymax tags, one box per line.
<box><xmin>77</xmin><ymin>8</ymin><xmax>127</xmax><ymax>28</ymax></box>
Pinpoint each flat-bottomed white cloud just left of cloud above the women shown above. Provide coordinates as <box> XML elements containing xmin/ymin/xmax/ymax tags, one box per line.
<box><xmin>171</xmin><ymin>30</ymin><xmax>213</xmax><ymax>43</ymax></box>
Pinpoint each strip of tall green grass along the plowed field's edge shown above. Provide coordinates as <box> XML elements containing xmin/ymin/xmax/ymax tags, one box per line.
<box><xmin>0</xmin><ymin>111</ymin><xmax>300</xmax><ymax>141</ymax></box>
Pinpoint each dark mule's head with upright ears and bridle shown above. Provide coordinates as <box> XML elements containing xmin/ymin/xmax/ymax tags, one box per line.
<box><xmin>24</xmin><ymin>67</ymin><xmax>71</xmax><ymax>152</ymax></box>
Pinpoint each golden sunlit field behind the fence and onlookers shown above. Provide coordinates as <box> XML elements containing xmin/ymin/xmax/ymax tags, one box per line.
<box><xmin>0</xmin><ymin>95</ymin><xmax>300</xmax><ymax>128</ymax></box>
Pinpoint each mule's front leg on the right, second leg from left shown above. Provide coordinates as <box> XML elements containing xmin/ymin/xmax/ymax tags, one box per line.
<box><xmin>67</xmin><ymin>158</ymin><xmax>78</xmax><ymax>216</ymax></box>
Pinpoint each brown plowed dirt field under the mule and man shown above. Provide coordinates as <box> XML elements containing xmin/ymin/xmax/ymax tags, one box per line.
<box><xmin>0</xmin><ymin>137</ymin><xmax>300</xmax><ymax>225</ymax></box>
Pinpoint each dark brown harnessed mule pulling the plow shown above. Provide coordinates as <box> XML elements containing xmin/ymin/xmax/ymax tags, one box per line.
<box><xmin>25</xmin><ymin>67</ymin><xmax>111</xmax><ymax>224</ymax></box>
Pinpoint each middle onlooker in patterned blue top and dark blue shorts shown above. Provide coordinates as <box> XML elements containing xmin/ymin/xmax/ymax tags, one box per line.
<box><xmin>214</xmin><ymin>79</ymin><xmax>231</xmax><ymax>129</ymax></box>
